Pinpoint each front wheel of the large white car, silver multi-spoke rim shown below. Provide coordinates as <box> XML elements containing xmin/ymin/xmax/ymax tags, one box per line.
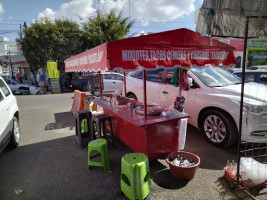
<box><xmin>200</xmin><ymin>110</ymin><xmax>237</xmax><ymax>147</ymax></box>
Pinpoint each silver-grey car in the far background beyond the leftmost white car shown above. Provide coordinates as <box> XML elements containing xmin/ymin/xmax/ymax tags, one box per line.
<box><xmin>5</xmin><ymin>79</ymin><xmax>41</xmax><ymax>94</ymax></box>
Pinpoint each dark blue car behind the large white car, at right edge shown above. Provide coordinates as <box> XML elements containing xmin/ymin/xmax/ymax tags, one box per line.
<box><xmin>233</xmin><ymin>70</ymin><xmax>267</xmax><ymax>85</ymax></box>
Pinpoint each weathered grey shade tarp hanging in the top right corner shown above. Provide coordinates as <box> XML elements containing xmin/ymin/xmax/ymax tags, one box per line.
<box><xmin>196</xmin><ymin>0</ymin><xmax>267</xmax><ymax>38</ymax></box>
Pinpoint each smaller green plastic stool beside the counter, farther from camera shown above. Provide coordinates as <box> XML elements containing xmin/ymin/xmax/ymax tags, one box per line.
<box><xmin>88</xmin><ymin>138</ymin><xmax>110</xmax><ymax>171</ymax></box>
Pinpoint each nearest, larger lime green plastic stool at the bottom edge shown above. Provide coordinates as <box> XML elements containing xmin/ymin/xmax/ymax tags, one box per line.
<box><xmin>121</xmin><ymin>153</ymin><xmax>151</xmax><ymax>199</ymax></box>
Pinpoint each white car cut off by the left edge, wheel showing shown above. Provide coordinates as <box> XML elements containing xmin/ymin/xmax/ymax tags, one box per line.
<box><xmin>0</xmin><ymin>77</ymin><xmax>20</xmax><ymax>152</ymax></box>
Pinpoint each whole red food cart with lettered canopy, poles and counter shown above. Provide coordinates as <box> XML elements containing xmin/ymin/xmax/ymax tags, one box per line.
<box><xmin>65</xmin><ymin>29</ymin><xmax>235</xmax><ymax>160</ymax></box>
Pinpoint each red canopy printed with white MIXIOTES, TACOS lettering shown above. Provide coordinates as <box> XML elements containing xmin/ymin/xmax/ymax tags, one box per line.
<box><xmin>65</xmin><ymin>28</ymin><xmax>235</xmax><ymax>72</ymax></box>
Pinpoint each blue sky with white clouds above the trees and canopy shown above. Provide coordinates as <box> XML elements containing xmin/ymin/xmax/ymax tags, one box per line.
<box><xmin>0</xmin><ymin>0</ymin><xmax>203</xmax><ymax>41</ymax></box>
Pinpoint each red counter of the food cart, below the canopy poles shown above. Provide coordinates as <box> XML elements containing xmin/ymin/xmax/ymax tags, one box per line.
<box><xmin>92</xmin><ymin>99</ymin><xmax>189</xmax><ymax>160</ymax></box>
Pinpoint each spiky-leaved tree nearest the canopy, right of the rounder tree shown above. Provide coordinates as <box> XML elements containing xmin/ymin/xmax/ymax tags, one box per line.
<box><xmin>83</xmin><ymin>10</ymin><xmax>134</xmax><ymax>49</ymax></box>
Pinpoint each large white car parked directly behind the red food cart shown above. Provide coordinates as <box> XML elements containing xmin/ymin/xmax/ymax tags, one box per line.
<box><xmin>126</xmin><ymin>67</ymin><xmax>267</xmax><ymax>146</ymax></box>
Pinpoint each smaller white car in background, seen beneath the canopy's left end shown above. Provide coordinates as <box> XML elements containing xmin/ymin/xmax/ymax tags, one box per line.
<box><xmin>88</xmin><ymin>72</ymin><xmax>123</xmax><ymax>96</ymax></box>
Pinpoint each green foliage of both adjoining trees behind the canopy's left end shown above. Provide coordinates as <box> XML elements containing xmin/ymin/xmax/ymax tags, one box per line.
<box><xmin>18</xmin><ymin>10</ymin><xmax>134</xmax><ymax>71</ymax></box>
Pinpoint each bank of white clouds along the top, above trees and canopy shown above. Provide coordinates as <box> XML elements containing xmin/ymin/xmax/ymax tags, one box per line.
<box><xmin>38</xmin><ymin>0</ymin><xmax>195</xmax><ymax>25</ymax></box>
